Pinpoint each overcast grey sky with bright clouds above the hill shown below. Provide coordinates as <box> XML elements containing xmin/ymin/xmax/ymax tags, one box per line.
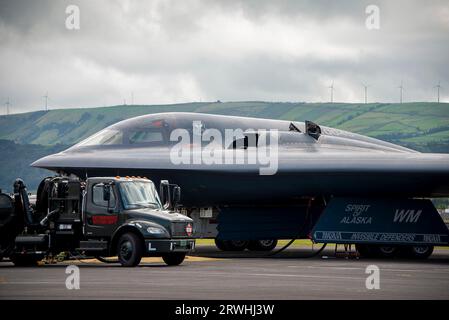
<box><xmin>0</xmin><ymin>0</ymin><xmax>449</xmax><ymax>114</ymax></box>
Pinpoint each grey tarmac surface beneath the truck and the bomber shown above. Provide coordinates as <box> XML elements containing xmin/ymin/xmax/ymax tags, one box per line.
<box><xmin>0</xmin><ymin>246</ymin><xmax>449</xmax><ymax>300</ymax></box>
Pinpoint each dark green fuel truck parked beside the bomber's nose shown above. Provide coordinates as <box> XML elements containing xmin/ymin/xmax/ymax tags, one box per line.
<box><xmin>0</xmin><ymin>176</ymin><xmax>195</xmax><ymax>267</ymax></box>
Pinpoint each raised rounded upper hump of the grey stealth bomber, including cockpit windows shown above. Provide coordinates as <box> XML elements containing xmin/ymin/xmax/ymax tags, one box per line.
<box><xmin>69</xmin><ymin>113</ymin><xmax>413</xmax><ymax>152</ymax></box>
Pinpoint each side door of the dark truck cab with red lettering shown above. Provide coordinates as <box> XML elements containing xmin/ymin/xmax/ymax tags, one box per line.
<box><xmin>85</xmin><ymin>182</ymin><xmax>119</xmax><ymax>237</ymax></box>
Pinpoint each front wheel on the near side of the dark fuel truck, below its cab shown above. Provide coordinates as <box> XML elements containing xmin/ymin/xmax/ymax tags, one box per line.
<box><xmin>117</xmin><ymin>232</ymin><xmax>143</xmax><ymax>267</ymax></box>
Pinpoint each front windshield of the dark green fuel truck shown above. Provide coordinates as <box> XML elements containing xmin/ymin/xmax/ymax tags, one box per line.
<box><xmin>119</xmin><ymin>181</ymin><xmax>162</xmax><ymax>209</ymax></box>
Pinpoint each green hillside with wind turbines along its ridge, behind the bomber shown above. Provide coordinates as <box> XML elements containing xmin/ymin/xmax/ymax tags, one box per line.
<box><xmin>0</xmin><ymin>101</ymin><xmax>449</xmax><ymax>152</ymax></box>
